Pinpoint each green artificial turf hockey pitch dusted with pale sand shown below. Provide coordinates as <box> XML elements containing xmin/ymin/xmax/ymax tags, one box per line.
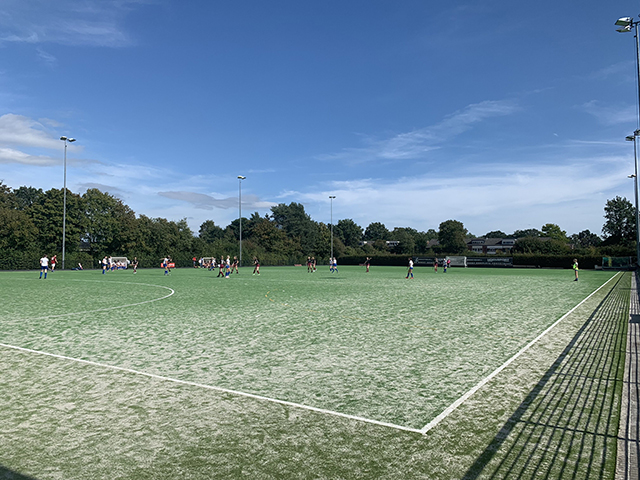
<box><xmin>0</xmin><ymin>267</ymin><xmax>632</xmax><ymax>478</ymax></box>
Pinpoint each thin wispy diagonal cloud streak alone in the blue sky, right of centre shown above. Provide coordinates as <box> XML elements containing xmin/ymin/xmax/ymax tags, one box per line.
<box><xmin>318</xmin><ymin>100</ymin><xmax>519</xmax><ymax>163</ymax></box>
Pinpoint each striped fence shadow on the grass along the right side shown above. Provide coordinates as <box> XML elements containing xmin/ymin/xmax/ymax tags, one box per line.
<box><xmin>463</xmin><ymin>275</ymin><xmax>630</xmax><ymax>480</ymax></box>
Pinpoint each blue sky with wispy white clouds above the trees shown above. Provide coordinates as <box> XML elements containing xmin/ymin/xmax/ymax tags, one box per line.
<box><xmin>0</xmin><ymin>0</ymin><xmax>640</xmax><ymax>236</ymax></box>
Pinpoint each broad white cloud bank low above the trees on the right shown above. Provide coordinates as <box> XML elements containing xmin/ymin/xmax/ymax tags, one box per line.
<box><xmin>286</xmin><ymin>157</ymin><xmax>632</xmax><ymax>234</ymax></box>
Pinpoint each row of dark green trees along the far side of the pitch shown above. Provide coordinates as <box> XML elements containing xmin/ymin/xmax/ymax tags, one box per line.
<box><xmin>0</xmin><ymin>182</ymin><xmax>636</xmax><ymax>270</ymax></box>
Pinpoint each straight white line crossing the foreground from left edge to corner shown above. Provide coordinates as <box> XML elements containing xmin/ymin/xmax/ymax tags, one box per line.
<box><xmin>0</xmin><ymin>343</ymin><xmax>422</xmax><ymax>433</ymax></box>
